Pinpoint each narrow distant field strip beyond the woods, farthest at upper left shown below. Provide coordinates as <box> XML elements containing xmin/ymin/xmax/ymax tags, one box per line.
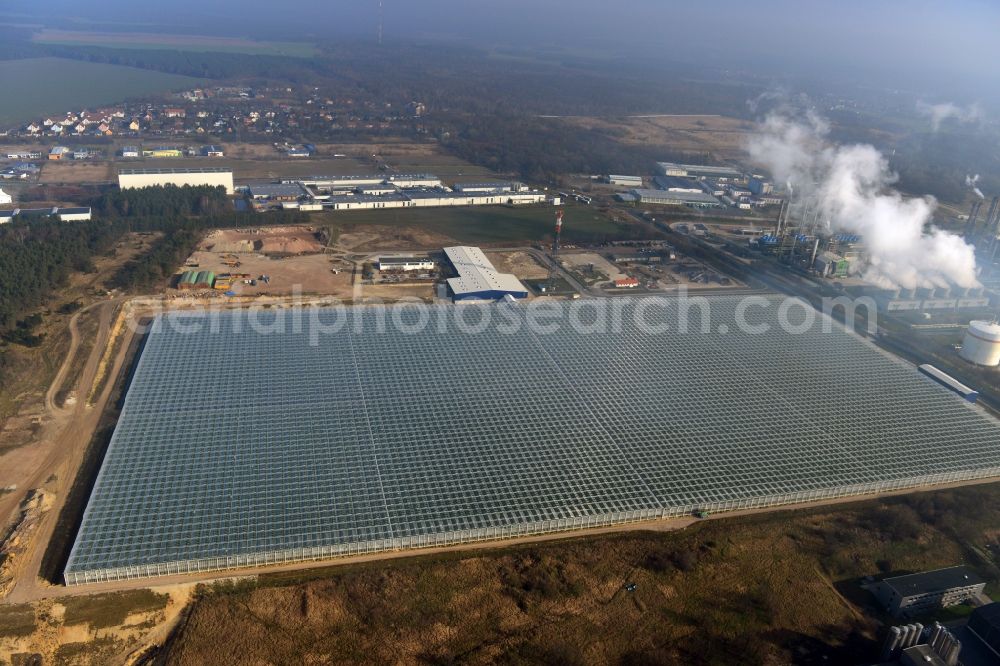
<box><xmin>32</xmin><ymin>30</ymin><xmax>319</xmax><ymax>58</ymax></box>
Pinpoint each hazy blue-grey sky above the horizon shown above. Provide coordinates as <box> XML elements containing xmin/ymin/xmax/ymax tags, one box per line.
<box><xmin>4</xmin><ymin>0</ymin><xmax>1000</xmax><ymax>99</ymax></box>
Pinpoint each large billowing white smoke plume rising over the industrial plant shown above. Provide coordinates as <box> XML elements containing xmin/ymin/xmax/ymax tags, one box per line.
<box><xmin>748</xmin><ymin>113</ymin><xmax>979</xmax><ymax>289</ymax></box>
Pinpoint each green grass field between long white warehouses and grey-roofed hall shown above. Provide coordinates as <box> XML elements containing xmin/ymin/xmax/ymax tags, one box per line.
<box><xmin>324</xmin><ymin>206</ymin><xmax>636</xmax><ymax>243</ymax></box>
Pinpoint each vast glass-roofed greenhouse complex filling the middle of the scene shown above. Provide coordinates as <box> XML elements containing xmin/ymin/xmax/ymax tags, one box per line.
<box><xmin>65</xmin><ymin>297</ymin><xmax>1000</xmax><ymax>584</ymax></box>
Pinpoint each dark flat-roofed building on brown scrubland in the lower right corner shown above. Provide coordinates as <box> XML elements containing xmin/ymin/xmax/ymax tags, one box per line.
<box><xmin>875</xmin><ymin>565</ymin><xmax>986</xmax><ymax>616</ymax></box>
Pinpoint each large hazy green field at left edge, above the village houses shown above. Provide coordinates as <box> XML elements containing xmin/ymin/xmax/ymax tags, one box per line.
<box><xmin>0</xmin><ymin>58</ymin><xmax>201</xmax><ymax>123</ymax></box>
